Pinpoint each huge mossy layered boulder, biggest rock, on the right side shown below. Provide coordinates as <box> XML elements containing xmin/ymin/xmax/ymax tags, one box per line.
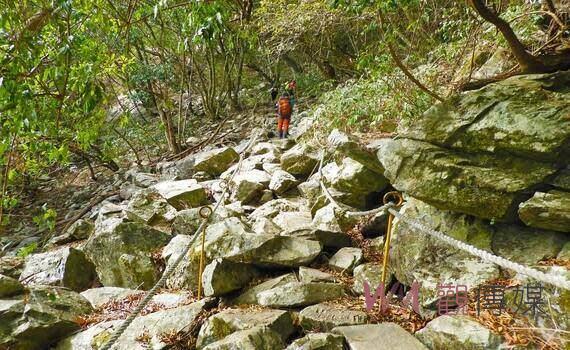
<box><xmin>378</xmin><ymin>72</ymin><xmax>570</xmax><ymax>222</ymax></box>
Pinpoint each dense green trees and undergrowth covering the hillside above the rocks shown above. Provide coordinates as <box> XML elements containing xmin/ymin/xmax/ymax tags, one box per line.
<box><xmin>0</xmin><ymin>0</ymin><xmax>569</xmax><ymax>232</ymax></box>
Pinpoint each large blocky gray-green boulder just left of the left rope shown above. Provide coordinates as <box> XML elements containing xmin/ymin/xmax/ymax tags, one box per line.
<box><xmin>84</xmin><ymin>222</ymin><xmax>171</xmax><ymax>289</ymax></box>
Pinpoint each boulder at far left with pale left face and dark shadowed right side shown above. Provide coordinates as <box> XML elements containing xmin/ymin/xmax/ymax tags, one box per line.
<box><xmin>20</xmin><ymin>247</ymin><xmax>96</xmax><ymax>292</ymax></box>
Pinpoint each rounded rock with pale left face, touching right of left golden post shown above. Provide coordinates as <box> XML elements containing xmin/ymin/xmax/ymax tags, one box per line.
<box><xmin>202</xmin><ymin>259</ymin><xmax>257</xmax><ymax>296</ymax></box>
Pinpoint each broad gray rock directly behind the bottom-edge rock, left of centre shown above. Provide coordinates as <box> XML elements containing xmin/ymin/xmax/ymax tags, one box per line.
<box><xmin>196</xmin><ymin>309</ymin><xmax>295</xmax><ymax>349</ymax></box>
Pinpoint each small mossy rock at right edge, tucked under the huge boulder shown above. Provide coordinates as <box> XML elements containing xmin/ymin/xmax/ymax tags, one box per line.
<box><xmin>519</xmin><ymin>191</ymin><xmax>570</xmax><ymax>232</ymax></box>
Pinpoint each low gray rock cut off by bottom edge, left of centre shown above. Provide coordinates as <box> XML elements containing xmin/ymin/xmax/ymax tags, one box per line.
<box><xmin>202</xmin><ymin>326</ymin><xmax>285</xmax><ymax>350</ymax></box>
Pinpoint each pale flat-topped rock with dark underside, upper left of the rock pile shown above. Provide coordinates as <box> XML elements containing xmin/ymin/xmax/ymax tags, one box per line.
<box><xmin>153</xmin><ymin>179</ymin><xmax>208</xmax><ymax>210</ymax></box>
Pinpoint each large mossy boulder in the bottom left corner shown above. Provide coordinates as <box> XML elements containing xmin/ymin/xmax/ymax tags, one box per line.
<box><xmin>0</xmin><ymin>286</ymin><xmax>92</xmax><ymax>350</ymax></box>
